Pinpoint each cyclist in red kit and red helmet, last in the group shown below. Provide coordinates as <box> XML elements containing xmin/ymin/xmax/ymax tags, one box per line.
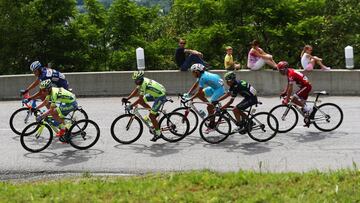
<box><xmin>277</xmin><ymin>61</ymin><xmax>312</xmax><ymax>120</ymax></box>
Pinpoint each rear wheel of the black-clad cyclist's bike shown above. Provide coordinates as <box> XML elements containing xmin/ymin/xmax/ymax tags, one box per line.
<box><xmin>246</xmin><ymin>112</ymin><xmax>279</xmax><ymax>142</ymax></box>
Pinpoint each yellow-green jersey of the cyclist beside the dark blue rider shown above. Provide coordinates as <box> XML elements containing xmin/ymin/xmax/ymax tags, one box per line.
<box><xmin>45</xmin><ymin>87</ymin><xmax>76</xmax><ymax>105</ymax></box>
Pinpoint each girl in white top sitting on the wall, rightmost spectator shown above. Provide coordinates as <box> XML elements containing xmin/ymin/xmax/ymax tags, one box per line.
<box><xmin>300</xmin><ymin>45</ymin><xmax>331</xmax><ymax>71</ymax></box>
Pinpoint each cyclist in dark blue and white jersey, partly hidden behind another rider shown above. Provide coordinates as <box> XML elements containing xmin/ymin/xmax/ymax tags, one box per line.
<box><xmin>24</xmin><ymin>61</ymin><xmax>69</xmax><ymax>103</ymax></box>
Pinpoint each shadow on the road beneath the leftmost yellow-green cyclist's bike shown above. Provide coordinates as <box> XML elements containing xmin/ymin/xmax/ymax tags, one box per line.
<box><xmin>24</xmin><ymin>149</ymin><xmax>104</xmax><ymax>166</ymax></box>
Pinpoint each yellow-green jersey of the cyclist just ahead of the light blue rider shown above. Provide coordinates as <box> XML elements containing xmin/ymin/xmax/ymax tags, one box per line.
<box><xmin>137</xmin><ymin>78</ymin><xmax>166</xmax><ymax>98</ymax></box>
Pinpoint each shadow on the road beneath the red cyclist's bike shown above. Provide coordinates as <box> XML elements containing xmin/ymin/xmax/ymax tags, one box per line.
<box><xmin>287</xmin><ymin>131</ymin><xmax>349</xmax><ymax>143</ymax></box>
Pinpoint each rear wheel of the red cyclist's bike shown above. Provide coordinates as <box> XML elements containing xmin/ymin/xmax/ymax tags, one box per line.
<box><xmin>310</xmin><ymin>103</ymin><xmax>344</xmax><ymax>132</ymax></box>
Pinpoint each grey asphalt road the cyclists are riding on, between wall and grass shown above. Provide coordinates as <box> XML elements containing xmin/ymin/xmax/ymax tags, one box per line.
<box><xmin>0</xmin><ymin>97</ymin><xmax>360</xmax><ymax>175</ymax></box>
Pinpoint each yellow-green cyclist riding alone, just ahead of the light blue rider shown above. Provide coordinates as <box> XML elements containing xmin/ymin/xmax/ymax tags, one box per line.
<box><xmin>122</xmin><ymin>71</ymin><xmax>166</xmax><ymax>142</ymax></box>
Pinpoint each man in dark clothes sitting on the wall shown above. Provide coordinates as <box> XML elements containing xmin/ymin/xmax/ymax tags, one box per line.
<box><xmin>175</xmin><ymin>39</ymin><xmax>205</xmax><ymax>71</ymax></box>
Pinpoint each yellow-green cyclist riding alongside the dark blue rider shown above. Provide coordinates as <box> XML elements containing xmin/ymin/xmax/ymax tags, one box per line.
<box><xmin>35</xmin><ymin>79</ymin><xmax>77</xmax><ymax>140</ymax></box>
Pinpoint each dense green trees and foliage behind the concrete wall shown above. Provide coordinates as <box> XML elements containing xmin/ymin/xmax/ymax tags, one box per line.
<box><xmin>0</xmin><ymin>0</ymin><xmax>360</xmax><ymax>74</ymax></box>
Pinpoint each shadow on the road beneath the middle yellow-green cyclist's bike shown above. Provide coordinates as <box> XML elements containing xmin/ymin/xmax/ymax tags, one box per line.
<box><xmin>115</xmin><ymin>142</ymin><xmax>186</xmax><ymax>157</ymax></box>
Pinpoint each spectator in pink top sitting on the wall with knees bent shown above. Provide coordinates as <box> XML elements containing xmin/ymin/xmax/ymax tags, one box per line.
<box><xmin>247</xmin><ymin>40</ymin><xmax>277</xmax><ymax>70</ymax></box>
